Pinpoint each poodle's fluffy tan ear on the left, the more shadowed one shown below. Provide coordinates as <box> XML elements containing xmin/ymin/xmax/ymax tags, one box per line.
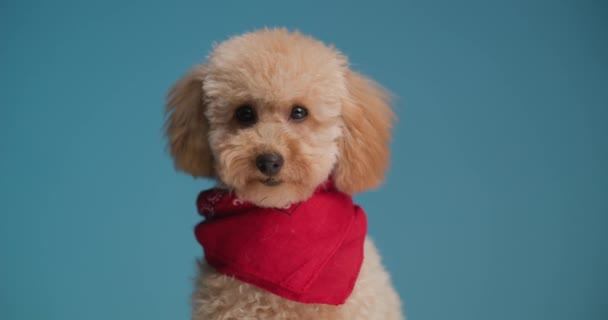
<box><xmin>165</xmin><ymin>65</ymin><xmax>214</xmax><ymax>177</ymax></box>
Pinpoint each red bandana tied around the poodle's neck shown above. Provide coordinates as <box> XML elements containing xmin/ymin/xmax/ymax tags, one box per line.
<box><xmin>195</xmin><ymin>182</ymin><xmax>367</xmax><ymax>305</ymax></box>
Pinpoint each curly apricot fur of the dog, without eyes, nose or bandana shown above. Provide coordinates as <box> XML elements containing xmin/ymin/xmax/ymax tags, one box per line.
<box><xmin>166</xmin><ymin>29</ymin><xmax>402</xmax><ymax>320</ymax></box>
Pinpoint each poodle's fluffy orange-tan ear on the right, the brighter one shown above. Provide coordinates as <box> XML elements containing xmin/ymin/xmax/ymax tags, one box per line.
<box><xmin>335</xmin><ymin>71</ymin><xmax>394</xmax><ymax>194</ymax></box>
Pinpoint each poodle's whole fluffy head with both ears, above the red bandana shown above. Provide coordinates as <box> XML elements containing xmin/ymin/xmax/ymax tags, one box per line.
<box><xmin>166</xmin><ymin>29</ymin><xmax>393</xmax><ymax>207</ymax></box>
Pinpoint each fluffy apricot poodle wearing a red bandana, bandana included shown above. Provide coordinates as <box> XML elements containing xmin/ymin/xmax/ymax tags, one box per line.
<box><xmin>165</xmin><ymin>28</ymin><xmax>403</xmax><ymax>320</ymax></box>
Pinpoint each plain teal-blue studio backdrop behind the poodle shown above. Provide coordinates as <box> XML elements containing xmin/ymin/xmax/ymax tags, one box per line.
<box><xmin>0</xmin><ymin>0</ymin><xmax>608</xmax><ymax>320</ymax></box>
